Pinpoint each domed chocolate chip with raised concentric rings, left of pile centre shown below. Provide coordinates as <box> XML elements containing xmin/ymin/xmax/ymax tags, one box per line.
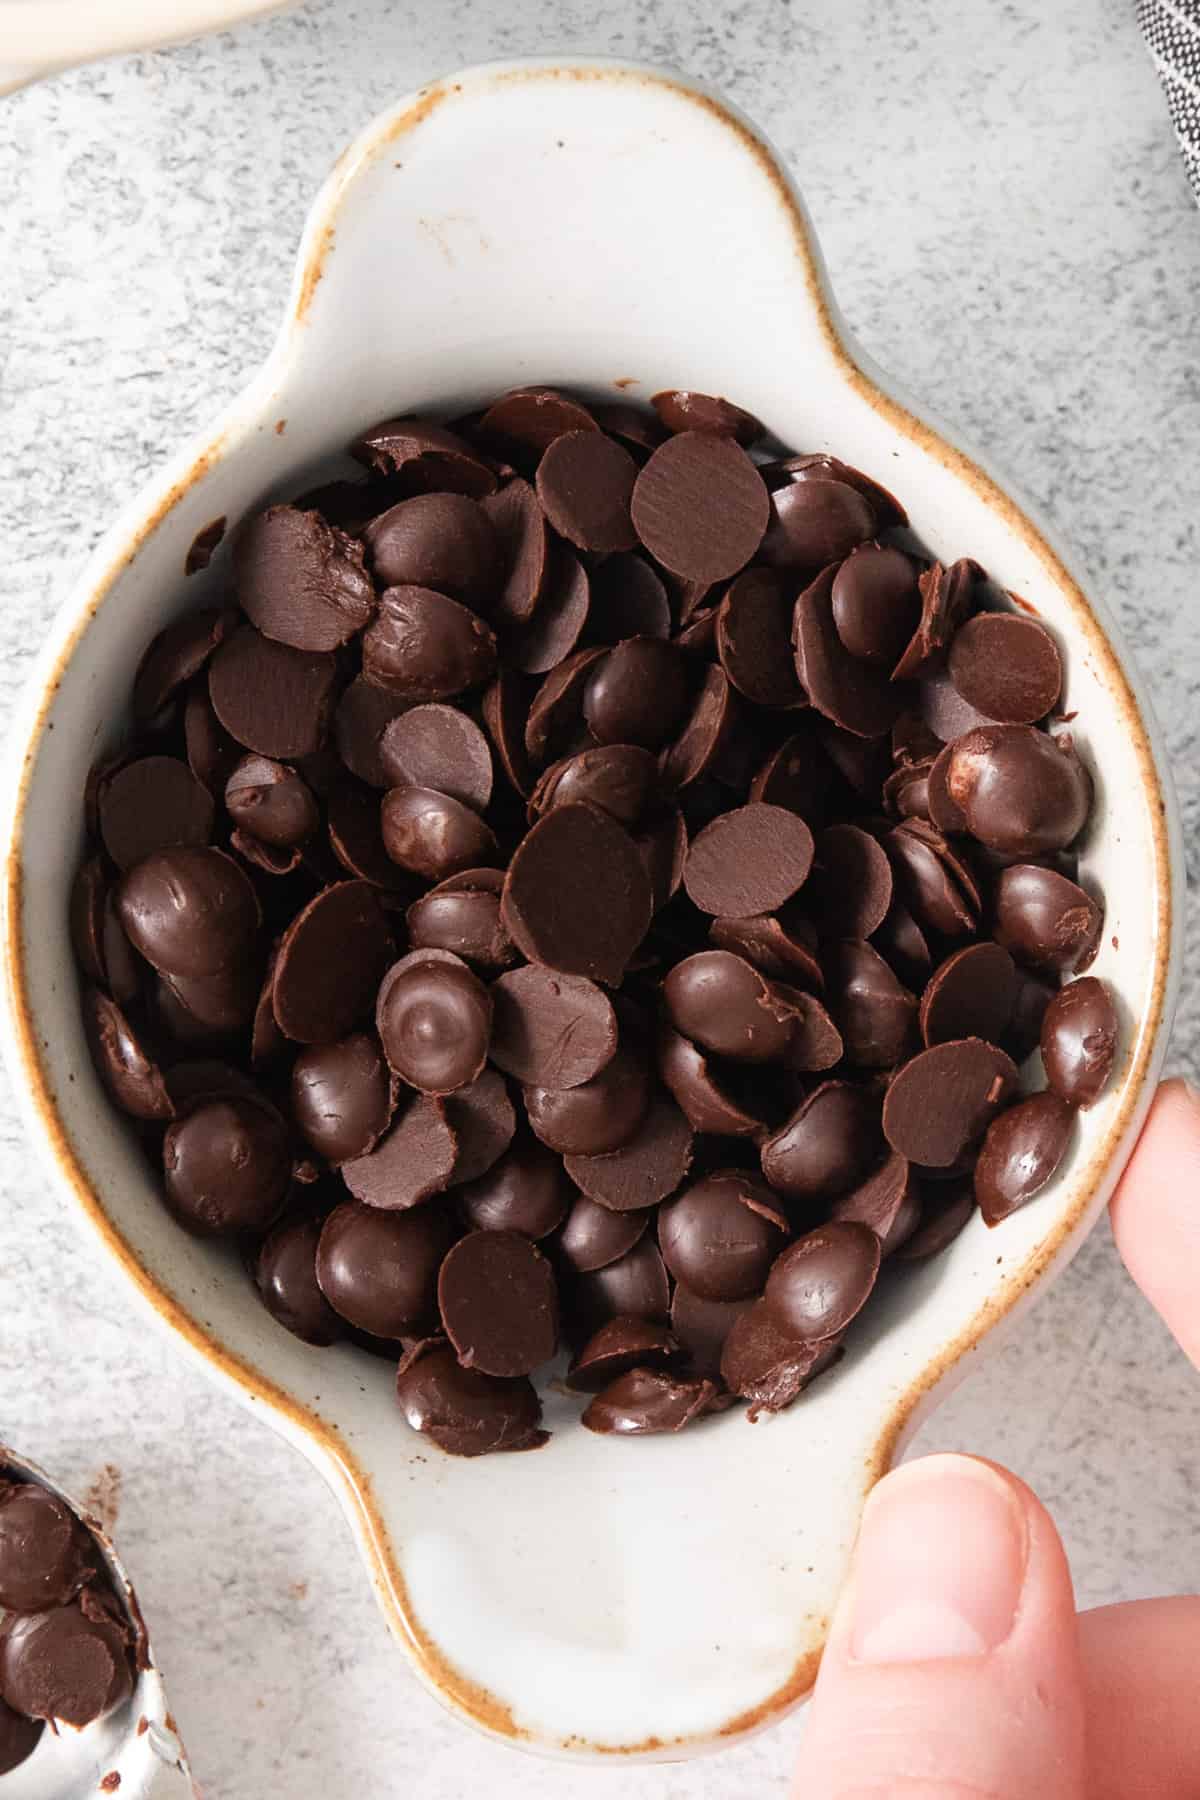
<box><xmin>376</xmin><ymin>950</ymin><xmax>491</xmax><ymax>1094</ymax></box>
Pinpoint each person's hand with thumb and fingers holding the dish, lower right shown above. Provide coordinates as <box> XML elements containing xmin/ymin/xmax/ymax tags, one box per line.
<box><xmin>793</xmin><ymin>1082</ymin><xmax>1200</xmax><ymax>1800</ymax></box>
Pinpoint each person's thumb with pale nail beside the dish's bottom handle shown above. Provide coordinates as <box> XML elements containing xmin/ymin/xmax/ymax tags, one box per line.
<box><xmin>793</xmin><ymin>1456</ymin><xmax>1085</xmax><ymax>1800</ymax></box>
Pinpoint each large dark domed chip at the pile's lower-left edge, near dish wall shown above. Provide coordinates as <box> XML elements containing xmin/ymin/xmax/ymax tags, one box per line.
<box><xmin>162</xmin><ymin>1098</ymin><xmax>291</xmax><ymax>1237</ymax></box>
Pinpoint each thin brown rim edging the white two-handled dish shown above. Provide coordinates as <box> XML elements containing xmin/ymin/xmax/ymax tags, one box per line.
<box><xmin>4</xmin><ymin>63</ymin><xmax>1173</xmax><ymax>1757</ymax></box>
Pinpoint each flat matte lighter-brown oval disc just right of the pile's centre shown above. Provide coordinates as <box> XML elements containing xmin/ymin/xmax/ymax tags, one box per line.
<box><xmin>684</xmin><ymin>801</ymin><xmax>813</xmax><ymax>918</ymax></box>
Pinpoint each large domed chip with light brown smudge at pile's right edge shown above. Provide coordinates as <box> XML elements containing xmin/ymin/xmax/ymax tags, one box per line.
<box><xmin>946</xmin><ymin>725</ymin><xmax>1092</xmax><ymax>857</ymax></box>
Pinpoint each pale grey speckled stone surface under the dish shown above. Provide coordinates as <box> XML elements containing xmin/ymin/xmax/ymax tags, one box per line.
<box><xmin>0</xmin><ymin>0</ymin><xmax>1200</xmax><ymax>1800</ymax></box>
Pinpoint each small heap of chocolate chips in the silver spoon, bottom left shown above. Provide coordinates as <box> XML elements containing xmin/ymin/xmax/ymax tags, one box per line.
<box><xmin>0</xmin><ymin>1469</ymin><xmax>140</xmax><ymax>1775</ymax></box>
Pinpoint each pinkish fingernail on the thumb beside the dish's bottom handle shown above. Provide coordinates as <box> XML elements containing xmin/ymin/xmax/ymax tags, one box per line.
<box><xmin>849</xmin><ymin>1456</ymin><xmax>1027</xmax><ymax>1663</ymax></box>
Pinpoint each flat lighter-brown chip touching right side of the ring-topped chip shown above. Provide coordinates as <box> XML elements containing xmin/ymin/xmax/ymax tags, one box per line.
<box><xmin>491</xmin><ymin>963</ymin><xmax>617</xmax><ymax>1089</ymax></box>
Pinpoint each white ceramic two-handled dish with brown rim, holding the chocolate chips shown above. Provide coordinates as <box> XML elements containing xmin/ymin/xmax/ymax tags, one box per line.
<box><xmin>4</xmin><ymin>63</ymin><xmax>1182</xmax><ymax>1757</ymax></box>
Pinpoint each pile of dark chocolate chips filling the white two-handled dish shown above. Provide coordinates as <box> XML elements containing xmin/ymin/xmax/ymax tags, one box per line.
<box><xmin>74</xmin><ymin>389</ymin><xmax>1117</xmax><ymax>1454</ymax></box>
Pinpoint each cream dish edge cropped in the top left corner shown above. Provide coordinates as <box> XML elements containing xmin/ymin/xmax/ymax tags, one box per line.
<box><xmin>0</xmin><ymin>0</ymin><xmax>286</xmax><ymax>94</ymax></box>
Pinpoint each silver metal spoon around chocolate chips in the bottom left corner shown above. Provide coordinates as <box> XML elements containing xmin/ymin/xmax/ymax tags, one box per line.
<box><xmin>0</xmin><ymin>1444</ymin><xmax>194</xmax><ymax>1800</ymax></box>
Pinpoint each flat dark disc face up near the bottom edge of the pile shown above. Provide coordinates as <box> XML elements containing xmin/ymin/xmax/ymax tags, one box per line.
<box><xmin>437</xmin><ymin>1231</ymin><xmax>558</xmax><ymax>1375</ymax></box>
